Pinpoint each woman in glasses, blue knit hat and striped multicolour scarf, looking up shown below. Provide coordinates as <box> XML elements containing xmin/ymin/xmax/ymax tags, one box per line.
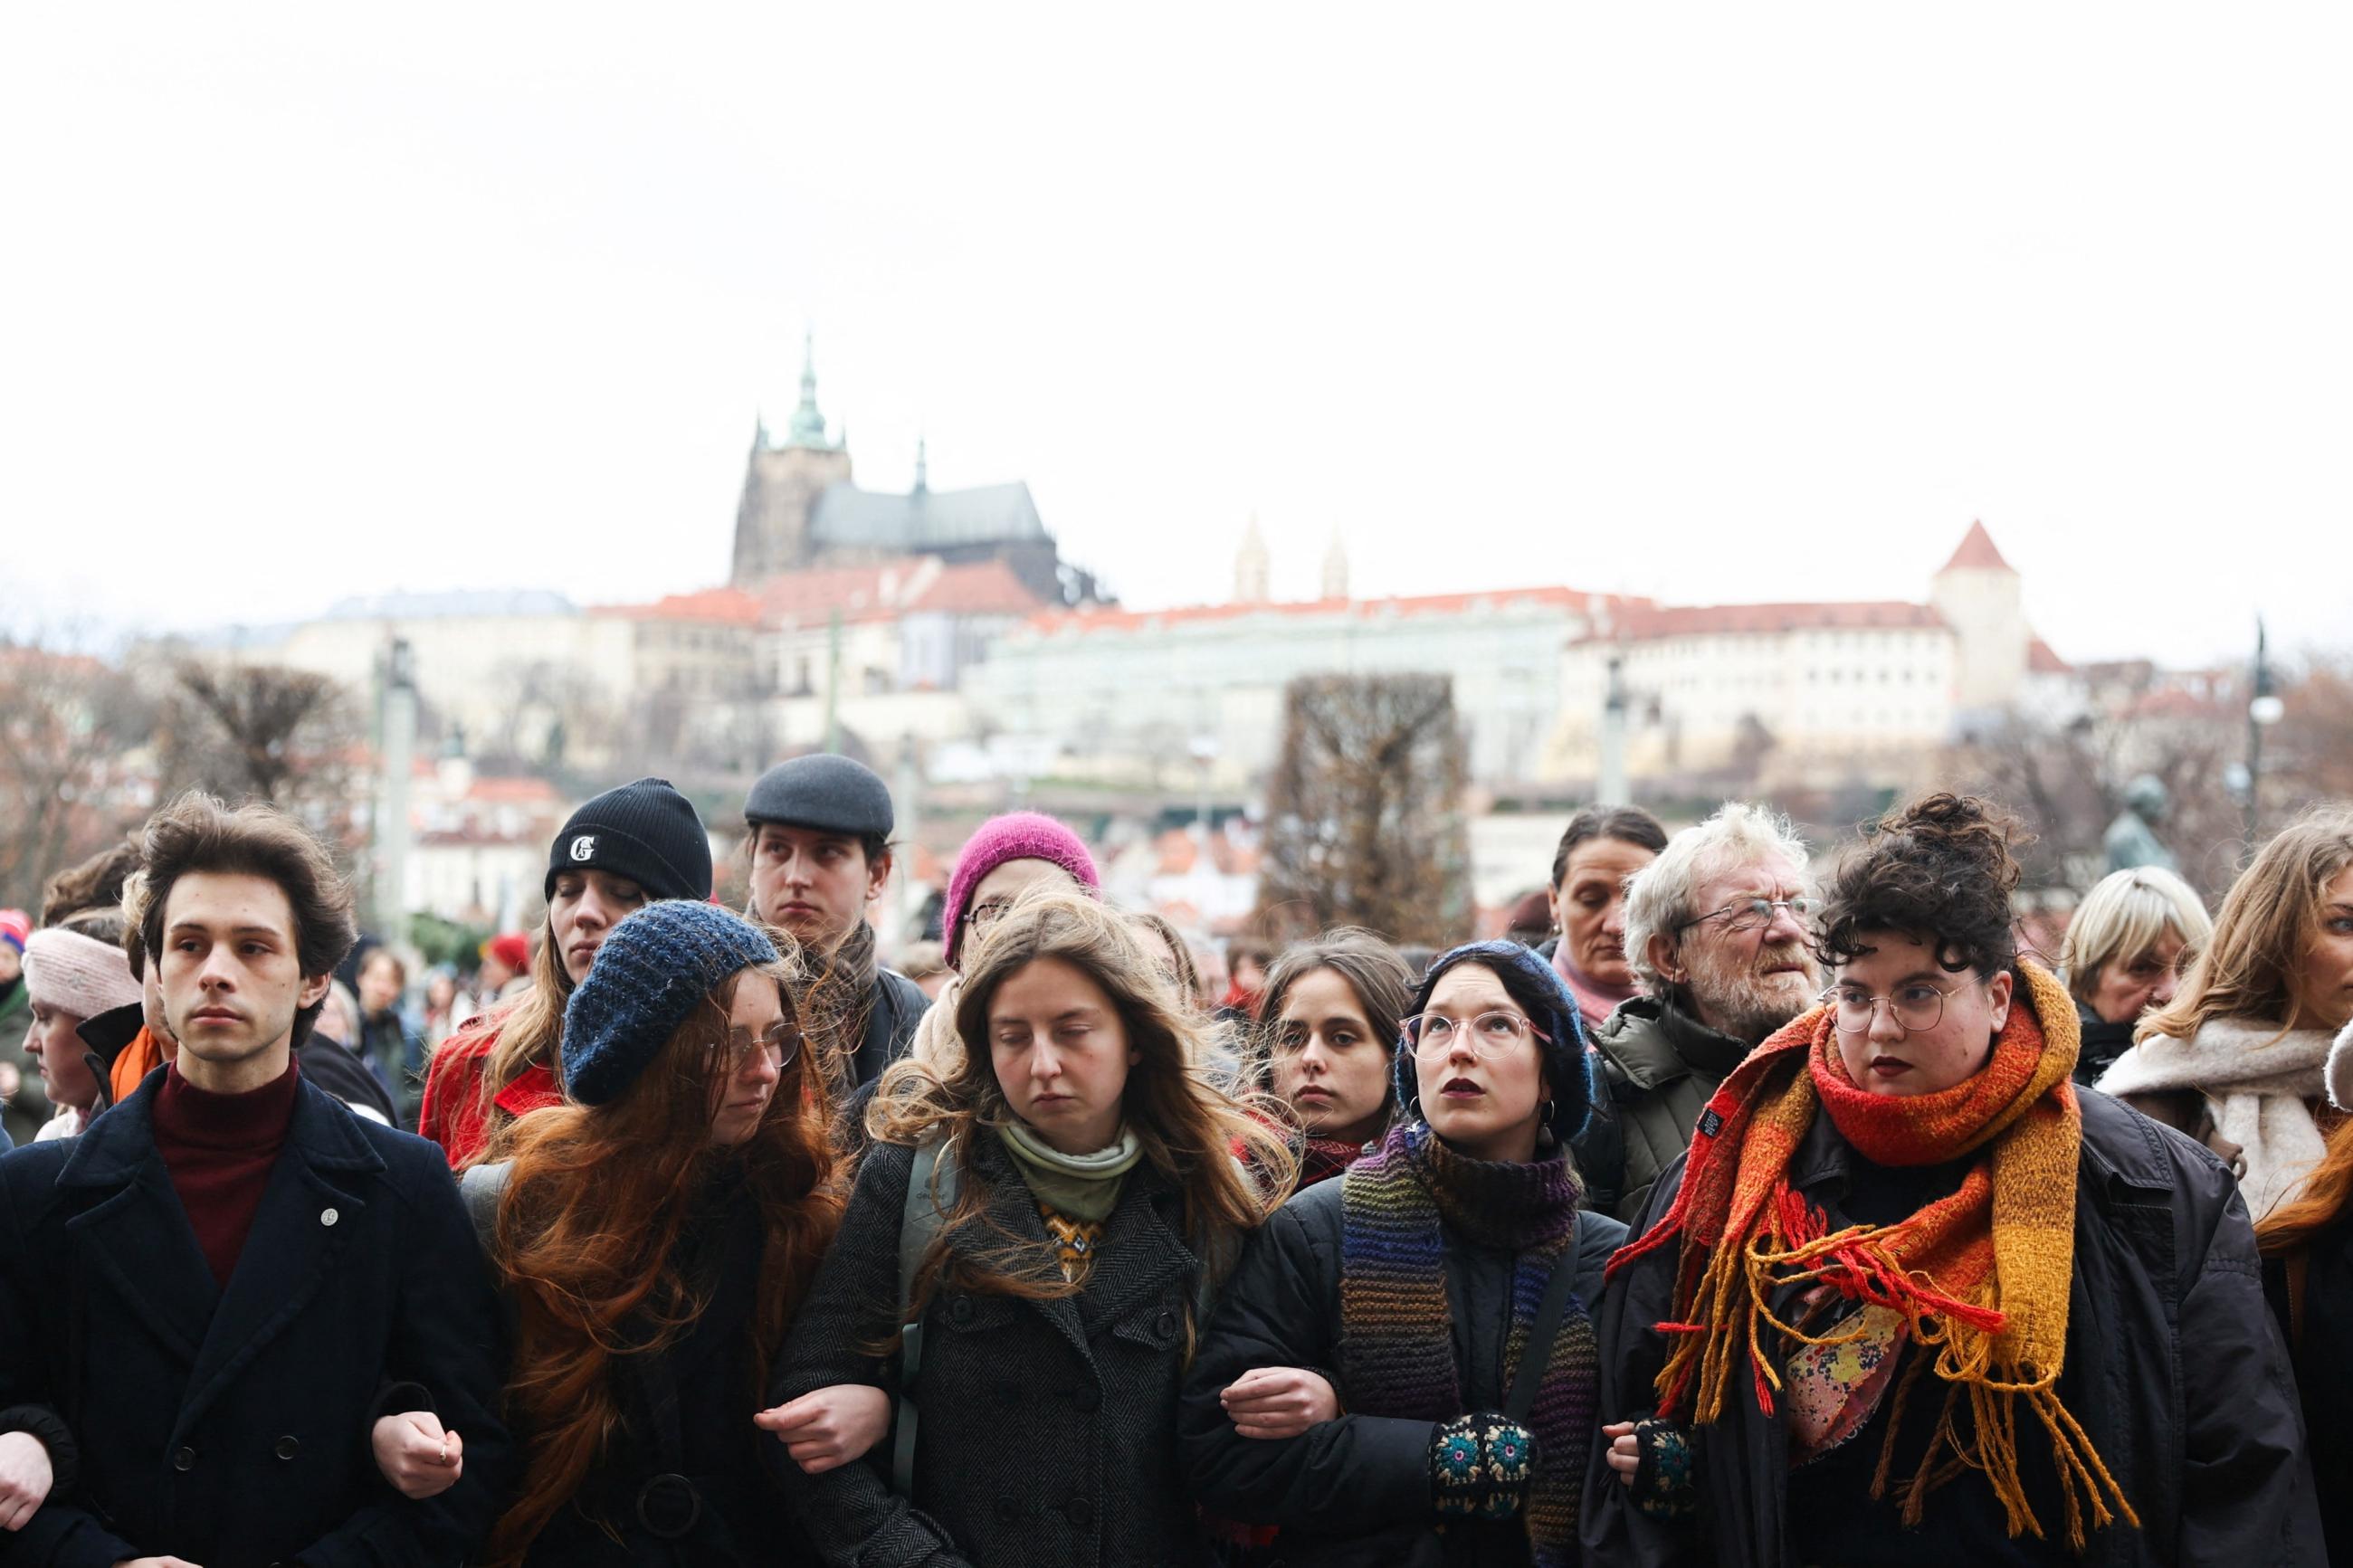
<box><xmin>1181</xmin><ymin>943</ymin><xmax>1626</xmax><ymax>1568</ymax></box>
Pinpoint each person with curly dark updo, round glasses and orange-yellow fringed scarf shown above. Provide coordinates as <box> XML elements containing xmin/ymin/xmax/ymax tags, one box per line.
<box><xmin>1586</xmin><ymin>794</ymin><xmax>2320</xmax><ymax>1565</ymax></box>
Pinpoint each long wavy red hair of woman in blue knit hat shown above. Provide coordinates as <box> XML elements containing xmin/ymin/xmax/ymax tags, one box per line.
<box><xmin>485</xmin><ymin>964</ymin><xmax>843</xmax><ymax>1568</ymax></box>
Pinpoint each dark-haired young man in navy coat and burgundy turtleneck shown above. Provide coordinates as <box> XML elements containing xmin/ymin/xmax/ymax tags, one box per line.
<box><xmin>0</xmin><ymin>794</ymin><xmax>513</xmax><ymax>1568</ymax></box>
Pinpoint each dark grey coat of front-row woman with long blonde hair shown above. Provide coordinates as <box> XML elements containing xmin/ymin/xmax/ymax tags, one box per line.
<box><xmin>769</xmin><ymin>1133</ymin><xmax>1207</xmax><ymax>1568</ymax></box>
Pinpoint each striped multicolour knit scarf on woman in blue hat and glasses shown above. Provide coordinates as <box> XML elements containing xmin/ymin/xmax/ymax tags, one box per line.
<box><xmin>1338</xmin><ymin>1121</ymin><xmax>1600</xmax><ymax>1568</ymax></box>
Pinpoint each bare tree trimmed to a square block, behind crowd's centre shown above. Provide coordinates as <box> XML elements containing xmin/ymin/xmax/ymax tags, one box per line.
<box><xmin>1256</xmin><ymin>675</ymin><xmax>1471</xmax><ymax>947</ymax></box>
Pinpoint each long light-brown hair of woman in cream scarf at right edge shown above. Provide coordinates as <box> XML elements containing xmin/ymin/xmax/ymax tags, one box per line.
<box><xmin>2132</xmin><ymin>806</ymin><xmax>2353</xmax><ymax>1041</ymax></box>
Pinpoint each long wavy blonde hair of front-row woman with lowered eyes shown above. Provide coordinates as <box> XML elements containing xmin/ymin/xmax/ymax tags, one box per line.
<box><xmin>866</xmin><ymin>887</ymin><xmax>1299</xmax><ymax>1314</ymax></box>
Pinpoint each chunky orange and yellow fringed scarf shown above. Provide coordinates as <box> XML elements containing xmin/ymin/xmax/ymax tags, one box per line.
<box><xmin>1609</xmin><ymin>962</ymin><xmax>2139</xmax><ymax>1552</ymax></box>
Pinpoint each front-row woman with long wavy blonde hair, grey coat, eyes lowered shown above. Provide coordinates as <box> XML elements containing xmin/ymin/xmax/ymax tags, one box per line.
<box><xmin>774</xmin><ymin>889</ymin><xmax>1291</xmax><ymax>1568</ymax></box>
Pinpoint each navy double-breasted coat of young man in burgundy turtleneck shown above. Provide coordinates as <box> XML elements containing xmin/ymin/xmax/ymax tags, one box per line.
<box><xmin>0</xmin><ymin>1074</ymin><xmax>513</xmax><ymax>1568</ymax></box>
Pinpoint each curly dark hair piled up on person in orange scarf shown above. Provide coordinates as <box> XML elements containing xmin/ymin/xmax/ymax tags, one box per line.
<box><xmin>1815</xmin><ymin>793</ymin><xmax>2028</xmax><ymax>980</ymax></box>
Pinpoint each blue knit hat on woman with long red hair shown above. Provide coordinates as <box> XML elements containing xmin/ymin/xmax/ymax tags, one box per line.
<box><xmin>562</xmin><ymin>898</ymin><xmax>776</xmax><ymax>1105</ymax></box>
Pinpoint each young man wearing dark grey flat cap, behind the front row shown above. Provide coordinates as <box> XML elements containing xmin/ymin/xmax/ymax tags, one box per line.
<box><xmin>744</xmin><ymin>752</ymin><xmax>932</xmax><ymax>1093</ymax></box>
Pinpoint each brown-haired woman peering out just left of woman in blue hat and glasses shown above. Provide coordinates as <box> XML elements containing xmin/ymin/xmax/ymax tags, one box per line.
<box><xmin>1259</xmin><ymin>927</ymin><xmax>1415</xmax><ymax>1187</ymax></box>
